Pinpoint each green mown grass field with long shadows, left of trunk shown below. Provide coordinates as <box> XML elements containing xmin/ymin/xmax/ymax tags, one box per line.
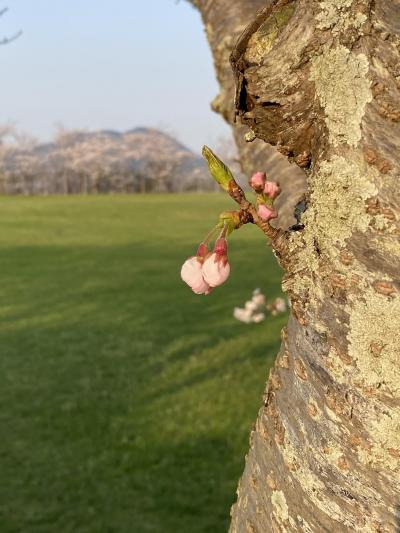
<box><xmin>0</xmin><ymin>194</ymin><xmax>286</xmax><ymax>533</ymax></box>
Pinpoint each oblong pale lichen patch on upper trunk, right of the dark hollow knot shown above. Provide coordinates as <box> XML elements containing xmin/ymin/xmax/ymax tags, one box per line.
<box><xmin>310</xmin><ymin>46</ymin><xmax>372</xmax><ymax>146</ymax></box>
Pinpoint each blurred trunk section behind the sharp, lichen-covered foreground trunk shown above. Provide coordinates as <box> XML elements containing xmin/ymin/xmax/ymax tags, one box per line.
<box><xmin>191</xmin><ymin>0</ymin><xmax>306</xmax><ymax>228</ymax></box>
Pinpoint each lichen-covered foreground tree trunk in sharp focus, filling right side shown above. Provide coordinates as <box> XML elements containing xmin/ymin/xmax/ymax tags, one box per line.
<box><xmin>190</xmin><ymin>0</ymin><xmax>400</xmax><ymax>533</ymax></box>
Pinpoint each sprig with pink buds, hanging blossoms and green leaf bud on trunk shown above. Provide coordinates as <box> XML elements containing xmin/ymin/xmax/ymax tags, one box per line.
<box><xmin>181</xmin><ymin>146</ymin><xmax>280</xmax><ymax>294</ymax></box>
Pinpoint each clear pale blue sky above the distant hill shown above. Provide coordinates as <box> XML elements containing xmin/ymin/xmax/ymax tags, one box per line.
<box><xmin>0</xmin><ymin>0</ymin><xmax>229</xmax><ymax>152</ymax></box>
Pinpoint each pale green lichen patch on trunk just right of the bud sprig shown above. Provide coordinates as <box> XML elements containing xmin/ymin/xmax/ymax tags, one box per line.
<box><xmin>284</xmin><ymin>153</ymin><xmax>378</xmax><ymax>312</ymax></box>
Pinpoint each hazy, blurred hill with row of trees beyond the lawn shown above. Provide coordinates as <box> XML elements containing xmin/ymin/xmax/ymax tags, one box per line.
<box><xmin>0</xmin><ymin>127</ymin><xmax>215</xmax><ymax>194</ymax></box>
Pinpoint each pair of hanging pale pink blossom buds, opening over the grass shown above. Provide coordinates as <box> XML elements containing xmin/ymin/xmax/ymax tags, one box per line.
<box><xmin>181</xmin><ymin>236</ymin><xmax>231</xmax><ymax>294</ymax></box>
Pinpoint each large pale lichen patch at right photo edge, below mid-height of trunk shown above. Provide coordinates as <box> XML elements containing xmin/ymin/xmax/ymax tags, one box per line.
<box><xmin>346</xmin><ymin>289</ymin><xmax>400</xmax><ymax>394</ymax></box>
